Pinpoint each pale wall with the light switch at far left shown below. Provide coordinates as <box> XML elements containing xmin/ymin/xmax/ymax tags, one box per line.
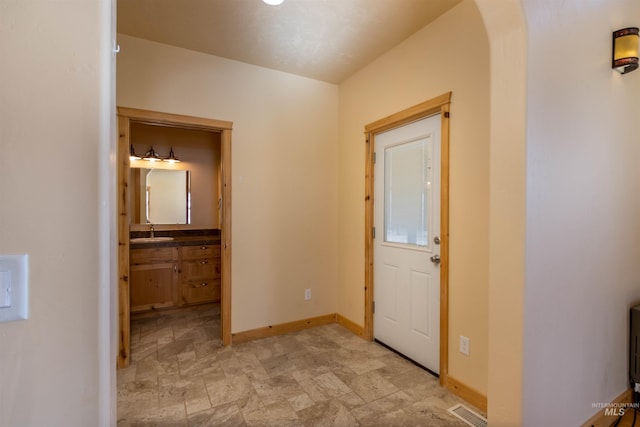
<box><xmin>0</xmin><ymin>0</ymin><xmax>115</xmax><ymax>427</ymax></box>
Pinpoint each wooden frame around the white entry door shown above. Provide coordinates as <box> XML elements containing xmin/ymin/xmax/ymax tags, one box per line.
<box><xmin>364</xmin><ymin>92</ymin><xmax>451</xmax><ymax>385</ymax></box>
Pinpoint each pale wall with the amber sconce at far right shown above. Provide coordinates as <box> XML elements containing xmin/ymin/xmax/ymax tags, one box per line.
<box><xmin>522</xmin><ymin>0</ymin><xmax>640</xmax><ymax>426</ymax></box>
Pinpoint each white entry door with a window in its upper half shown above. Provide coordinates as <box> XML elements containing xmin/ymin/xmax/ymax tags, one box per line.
<box><xmin>373</xmin><ymin>114</ymin><xmax>441</xmax><ymax>373</ymax></box>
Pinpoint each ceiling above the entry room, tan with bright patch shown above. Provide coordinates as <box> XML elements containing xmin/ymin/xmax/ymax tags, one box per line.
<box><xmin>118</xmin><ymin>0</ymin><xmax>462</xmax><ymax>83</ymax></box>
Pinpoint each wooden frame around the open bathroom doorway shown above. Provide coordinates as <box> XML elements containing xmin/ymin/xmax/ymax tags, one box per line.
<box><xmin>116</xmin><ymin>107</ymin><xmax>233</xmax><ymax>368</ymax></box>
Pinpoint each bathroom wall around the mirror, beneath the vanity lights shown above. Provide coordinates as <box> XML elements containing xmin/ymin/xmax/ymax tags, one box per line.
<box><xmin>131</xmin><ymin>123</ymin><xmax>220</xmax><ymax>228</ymax></box>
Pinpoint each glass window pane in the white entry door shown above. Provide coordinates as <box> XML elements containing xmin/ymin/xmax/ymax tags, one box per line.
<box><xmin>384</xmin><ymin>138</ymin><xmax>432</xmax><ymax>248</ymax></box>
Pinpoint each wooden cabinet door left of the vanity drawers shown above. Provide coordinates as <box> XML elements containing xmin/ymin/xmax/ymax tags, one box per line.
<box><xmin>130</xmin><ymin>262</ymin><xmax>178</xmax><ymax>312</ymax></box>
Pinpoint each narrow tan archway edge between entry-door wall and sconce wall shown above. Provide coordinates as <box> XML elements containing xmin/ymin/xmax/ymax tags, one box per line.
<box><xmin>476</xmin><ymin>0</ymin><xmax>524</xmax><ymax>427</ymax></box>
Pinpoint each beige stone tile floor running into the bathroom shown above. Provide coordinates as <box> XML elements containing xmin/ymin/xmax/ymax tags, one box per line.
<box><xmin>117</xmin><ymin>305</ymin><xmax>466</xmax><ymax>427</ymax></box>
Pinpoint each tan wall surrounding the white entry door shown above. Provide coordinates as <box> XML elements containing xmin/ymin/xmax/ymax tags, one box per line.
<box><xmin>338</xmin><ymin>0</ymin><xmax>489</xmax><ymax>394</ymax></box>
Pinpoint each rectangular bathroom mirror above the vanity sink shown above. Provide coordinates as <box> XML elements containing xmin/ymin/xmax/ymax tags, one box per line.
<box><xmin>129</xmin><ymin>168</ymin><xmax>191</xmax><ymax>224</ymax></box>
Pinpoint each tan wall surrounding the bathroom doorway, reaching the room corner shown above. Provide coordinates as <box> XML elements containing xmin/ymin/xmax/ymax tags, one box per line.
<box><xmin>117</xmin><ymin>35</ymin><xmax>338</xmax><ymax>332</ymax></box>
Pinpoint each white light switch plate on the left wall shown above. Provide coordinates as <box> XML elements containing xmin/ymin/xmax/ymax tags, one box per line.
<box><xmin>0</xmin><ymin>254</ymin><xmax>29</xmax><ymax>322</ymax></box>
